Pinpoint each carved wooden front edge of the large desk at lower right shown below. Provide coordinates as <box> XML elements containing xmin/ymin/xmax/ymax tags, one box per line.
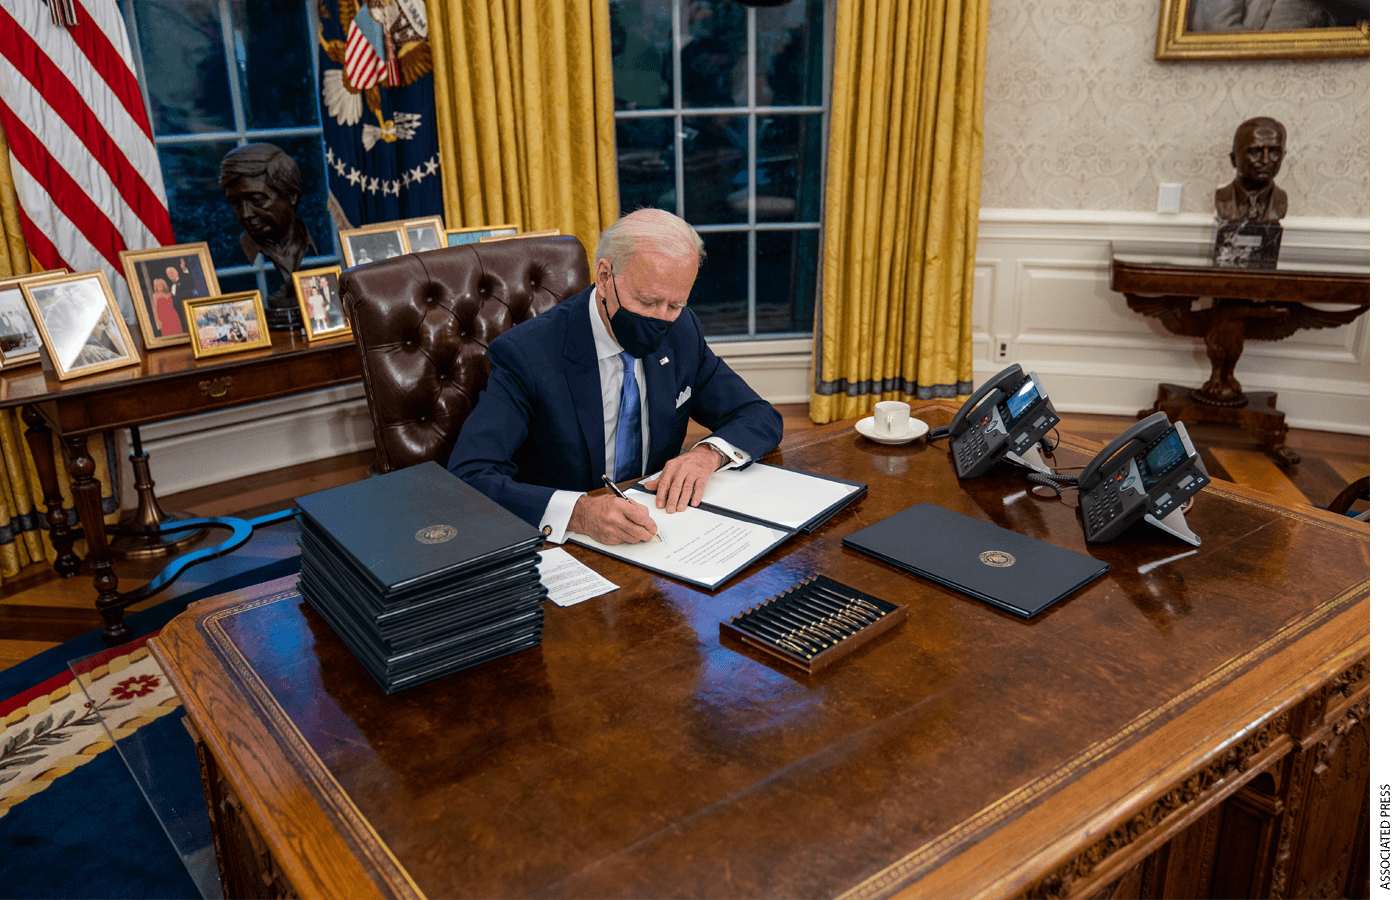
<box><xmin>862</xmin><ymin>590</ymin><xmax>1371</xmax><ymax>899</ymax></box>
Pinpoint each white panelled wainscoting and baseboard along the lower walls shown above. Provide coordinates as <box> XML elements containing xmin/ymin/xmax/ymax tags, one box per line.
<box><xmin>122</xmin><ymin>209</ymin><xmax>1371</xmax><ymax>505</ymax></box>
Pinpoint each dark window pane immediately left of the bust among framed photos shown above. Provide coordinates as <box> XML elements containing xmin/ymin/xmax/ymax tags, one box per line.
<box><xmin>160</xmin><ymin>141</ymin><xmax>248</xmax><ymax>269</ymax></box>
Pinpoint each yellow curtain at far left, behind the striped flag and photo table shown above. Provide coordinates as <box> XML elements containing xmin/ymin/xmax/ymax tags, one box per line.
<box><xmin>0</xmin><ymin>129</ymin><xmax>120</xmax><ymax>581</ymax></box>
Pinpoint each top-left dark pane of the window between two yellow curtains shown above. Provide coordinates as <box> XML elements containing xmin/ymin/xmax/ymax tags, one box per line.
<box><xmin>608</xmin><ymin>0</ymin><xmax>673</xmax><ymax>109</ymax></box>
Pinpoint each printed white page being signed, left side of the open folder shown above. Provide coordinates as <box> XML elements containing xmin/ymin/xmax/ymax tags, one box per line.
<box><xmin>568</xmin><ymin>488</ymin><xmax>792</xmax><ymax>591</ymax></box>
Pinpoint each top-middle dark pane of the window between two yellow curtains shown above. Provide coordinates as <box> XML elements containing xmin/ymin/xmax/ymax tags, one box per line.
<box><xmin>680</xmin><ymin>0</ymin><xmax>749</xmax><ymax>106</ymax></box>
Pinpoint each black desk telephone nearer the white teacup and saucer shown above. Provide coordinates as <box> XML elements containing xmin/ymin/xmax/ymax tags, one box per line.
<box><xmin>928</xmin><ymin>365</ymin><xmax>1060</xmax><ymax>479</ymax></box>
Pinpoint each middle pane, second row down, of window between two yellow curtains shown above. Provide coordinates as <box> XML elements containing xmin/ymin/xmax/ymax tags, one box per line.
<box><xmin>682</xmin><ymin>116</ymin><xmax>749</xmax><ymax>225</ymax></box>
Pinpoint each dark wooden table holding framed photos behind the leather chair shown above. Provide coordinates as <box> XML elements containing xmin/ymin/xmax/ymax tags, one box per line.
<box><xmin>0</xmin><ymin>332</ymin><xmax>363</xmax><ymax>645</ymax></box>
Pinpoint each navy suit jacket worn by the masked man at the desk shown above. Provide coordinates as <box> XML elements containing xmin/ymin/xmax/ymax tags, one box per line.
<box><xmin>448</xmin><ymin>288</ymin><xmax>783</xmax><ymax>525</ymax></box>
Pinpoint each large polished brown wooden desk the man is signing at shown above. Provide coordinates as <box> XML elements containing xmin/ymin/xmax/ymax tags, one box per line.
<box><xmin>151</xmin><ymin>402</ymin><xmax>1371</xmax><ymax>897</ymax></box>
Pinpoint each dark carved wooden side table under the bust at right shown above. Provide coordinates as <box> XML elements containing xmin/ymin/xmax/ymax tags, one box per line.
<box><xmin>1110</xmin><ymin>245</ymin><xmax>1371</xmax><ymax>466</ymax></box>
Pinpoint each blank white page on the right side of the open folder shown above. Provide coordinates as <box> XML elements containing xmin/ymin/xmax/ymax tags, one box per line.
<box><xmin>704</xmin><ymin>462</ymin><xmax>865</xmax><ymax>530</ymax></box>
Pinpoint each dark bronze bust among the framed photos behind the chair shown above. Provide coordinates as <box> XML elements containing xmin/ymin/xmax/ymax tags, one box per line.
<box><xmin>218</xmin><ymin>144</ymin><xmax>316</xmax><ymax>330</ymax></box>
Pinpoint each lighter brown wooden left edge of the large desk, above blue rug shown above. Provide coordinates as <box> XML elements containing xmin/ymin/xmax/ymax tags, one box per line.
<box><xmin>150</xmin><ymin>575</ymin><xmax>423</xmax><ymax>897</ymax></box>
